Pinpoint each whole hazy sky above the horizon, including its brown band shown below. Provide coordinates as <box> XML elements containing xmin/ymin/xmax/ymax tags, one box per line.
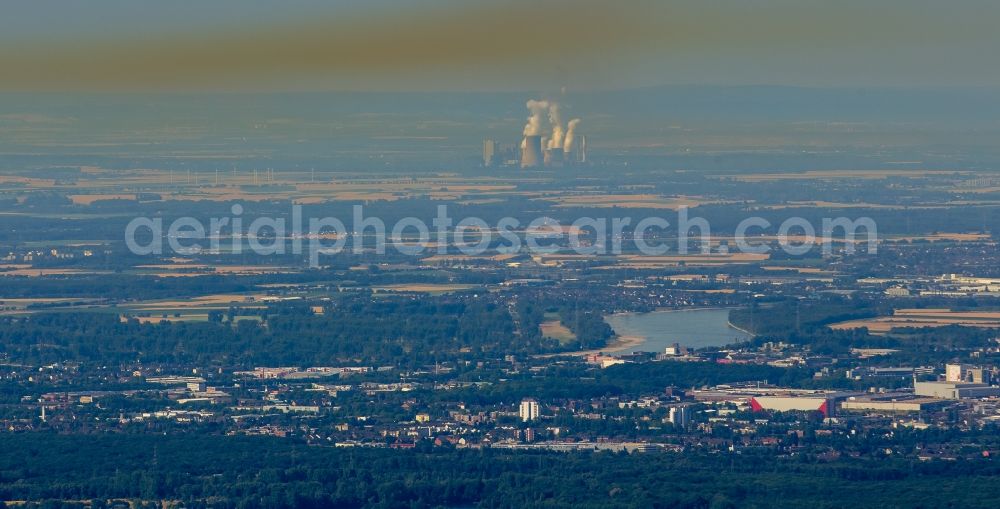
<box><xmin>0</xmin><ymin>0</ymin><xmax>1000</xmax><ymax>91</ymax></box>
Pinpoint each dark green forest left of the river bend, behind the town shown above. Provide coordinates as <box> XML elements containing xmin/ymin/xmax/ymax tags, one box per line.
<box><xmin>0</xmin><ymin>299</ymin><xmax>539</xmax><ymax>365</ymax></box>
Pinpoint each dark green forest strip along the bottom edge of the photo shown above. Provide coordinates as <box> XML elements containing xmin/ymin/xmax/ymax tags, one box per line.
<box><xmin>0</xmin><ymin>433</ymin><xmax>1000</xmax><ymax>509</ymax></box>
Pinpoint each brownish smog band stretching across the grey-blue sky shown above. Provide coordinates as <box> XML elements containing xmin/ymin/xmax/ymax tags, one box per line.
<box><xmin>0</xmin><ymin>0</ymin><xmax>980</xmax><ymax>91</ymax></box>
